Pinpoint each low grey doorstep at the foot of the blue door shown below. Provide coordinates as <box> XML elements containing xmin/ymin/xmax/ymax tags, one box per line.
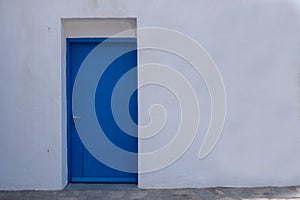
<box><xmin>64</xmin><ymin>183</ymin><xmax>139</xmax><ymax>190</ymax></box>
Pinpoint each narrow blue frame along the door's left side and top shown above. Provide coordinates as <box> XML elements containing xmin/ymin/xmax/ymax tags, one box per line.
<box><xmin>65</xmin><ymin>37</ymin><xmax>139</xmax><ymax>184</ymax></box>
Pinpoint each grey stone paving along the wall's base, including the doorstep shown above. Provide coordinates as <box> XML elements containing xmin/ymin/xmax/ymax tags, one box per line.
<box><xmin>0</xmin><ymin>184</ymin><xmax>300</xmax><ymax>200</ymax></box>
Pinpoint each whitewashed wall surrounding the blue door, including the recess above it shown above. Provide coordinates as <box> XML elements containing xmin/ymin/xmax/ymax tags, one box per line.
<box><xmin>0</xmin><ymin>0</ymin><xmax>300</xmax><ymax>190</ymax></box>
